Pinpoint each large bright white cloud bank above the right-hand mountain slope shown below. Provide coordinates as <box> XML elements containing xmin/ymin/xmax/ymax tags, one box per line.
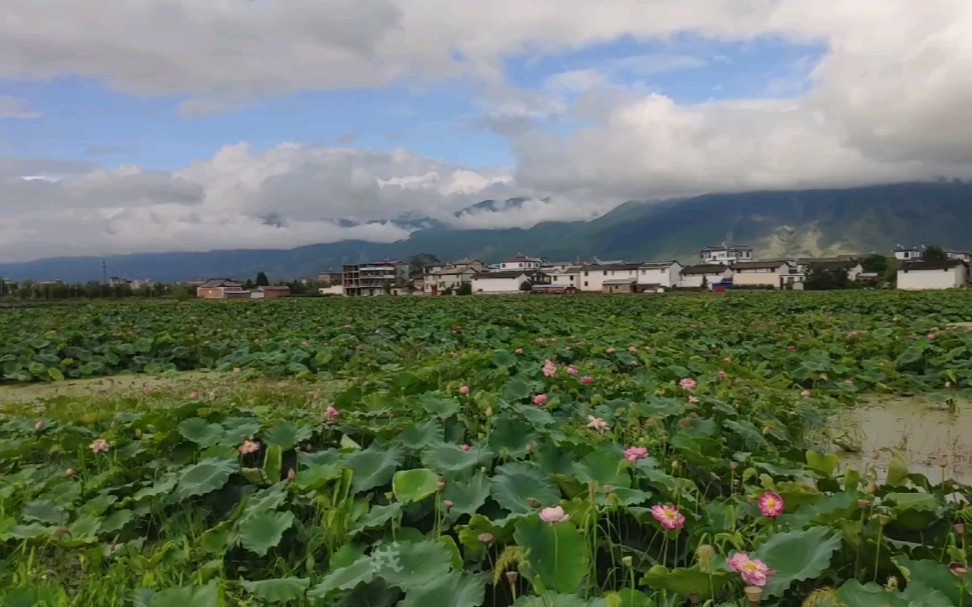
<box><xmin>517</xmin><ymin>0</ymin><xmax>972</xmax><ymax>200</ymax></box>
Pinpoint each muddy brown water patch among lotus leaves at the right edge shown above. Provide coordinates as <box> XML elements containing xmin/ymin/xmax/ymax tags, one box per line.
<box><xmin>829</xmin><ymin>396</ymin><xmax>972</xmax><ymax>484</ymax></box>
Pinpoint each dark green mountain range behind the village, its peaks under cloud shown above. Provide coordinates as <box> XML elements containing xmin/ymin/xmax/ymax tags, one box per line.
<box><xmin>0</xmin><ymin>180</ymin><xmax>972</xmax><ymax>282</ymax></box>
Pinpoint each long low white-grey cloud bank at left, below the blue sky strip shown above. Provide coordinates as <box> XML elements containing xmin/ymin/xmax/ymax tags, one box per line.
<box><xmin>0</xmin><ymin>143</ymin><xmax>590</xmax><ymax>262</ymax></box>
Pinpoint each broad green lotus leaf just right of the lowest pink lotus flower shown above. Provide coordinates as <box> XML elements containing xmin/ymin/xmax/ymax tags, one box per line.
<box><xmin>754</xmin><ymin>527</ymin><xmax>840</xmax><ymax>598</ymax></box>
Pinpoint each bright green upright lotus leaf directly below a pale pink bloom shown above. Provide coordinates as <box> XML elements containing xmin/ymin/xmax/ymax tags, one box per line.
<box><xmin>513</xmin><ymin>516</ymin><xmax>590</xmax><ymax>593</ymax></box>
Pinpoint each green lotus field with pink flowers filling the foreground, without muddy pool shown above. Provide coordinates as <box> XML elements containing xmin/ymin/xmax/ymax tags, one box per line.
<box><xmin>0</xmin><ymin>292</ymin><xmax>972</xmax><ymax>607</ymax></box>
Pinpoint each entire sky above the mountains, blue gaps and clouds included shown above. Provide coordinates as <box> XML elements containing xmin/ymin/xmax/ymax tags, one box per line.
<box><xmin>0</xmin><ymin>0</ymin><xmax>972</xmax><ymax>263</ymax></box>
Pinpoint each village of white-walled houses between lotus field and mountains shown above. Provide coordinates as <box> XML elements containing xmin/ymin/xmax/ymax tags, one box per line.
<box><xmin>195</xmin><ymin>245</ymin><xmax>972</xmax><ymax>299</ymax></box>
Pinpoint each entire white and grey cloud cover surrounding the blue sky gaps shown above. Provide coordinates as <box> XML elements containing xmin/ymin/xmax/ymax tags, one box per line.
<box><xmin>0</xmin><ymin>0</ymin><xmax>972</xmax><ymax>259</ymax></box>
